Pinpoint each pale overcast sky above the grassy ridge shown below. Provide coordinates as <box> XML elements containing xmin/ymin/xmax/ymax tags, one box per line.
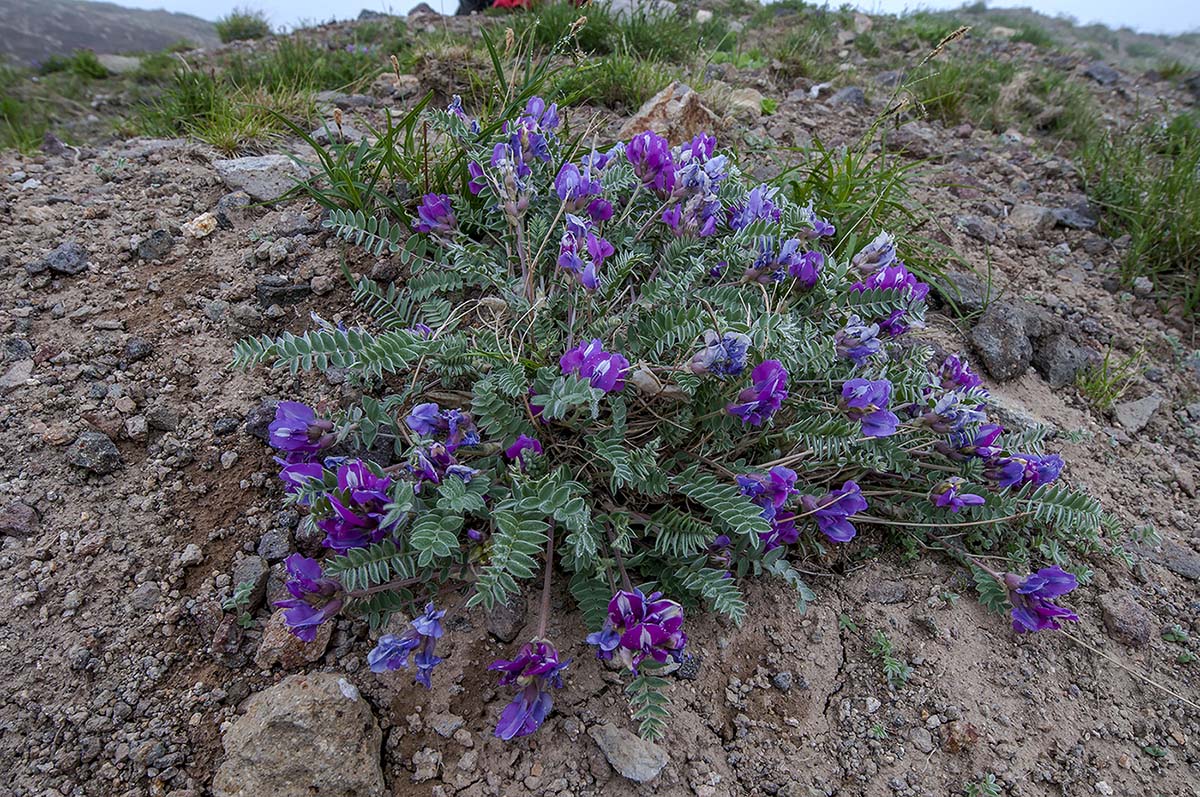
<box><xmin>88</xmin><ymin>0</ymin><xmax>1200</xmax><ymax>34</ymax></box>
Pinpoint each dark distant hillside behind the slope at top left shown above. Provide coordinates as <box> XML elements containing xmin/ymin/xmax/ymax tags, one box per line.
<box><xmin>0</xmin><ymin>0</ymin><xmax>218</xmax><ymax>64</ymax></box>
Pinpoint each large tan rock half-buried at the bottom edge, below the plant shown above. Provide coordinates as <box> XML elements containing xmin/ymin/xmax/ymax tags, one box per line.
<box><xmin>212</xmin><ymin>672</ymin><xmax>384</xmax><ymax>797</ymax></box>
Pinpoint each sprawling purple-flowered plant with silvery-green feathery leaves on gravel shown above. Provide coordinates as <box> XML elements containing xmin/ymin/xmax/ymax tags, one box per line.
<box><xmin>236</xmin><ymin>97</ymin><xmax>1102</xmax><ymax>739</ymax></box>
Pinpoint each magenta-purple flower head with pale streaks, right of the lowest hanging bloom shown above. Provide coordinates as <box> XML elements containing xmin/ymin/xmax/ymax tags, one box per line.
<box><xmin>588</xmin><ymin>589</ymin><xmax>688</xmax><ymax>675</ymax></box>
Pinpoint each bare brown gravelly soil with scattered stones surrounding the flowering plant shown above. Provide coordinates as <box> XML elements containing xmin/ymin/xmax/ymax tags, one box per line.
<box><xmin>0</xmin><ymin>7</ymin><xmax>1200</xmax><ymax>797</ymax></box>
